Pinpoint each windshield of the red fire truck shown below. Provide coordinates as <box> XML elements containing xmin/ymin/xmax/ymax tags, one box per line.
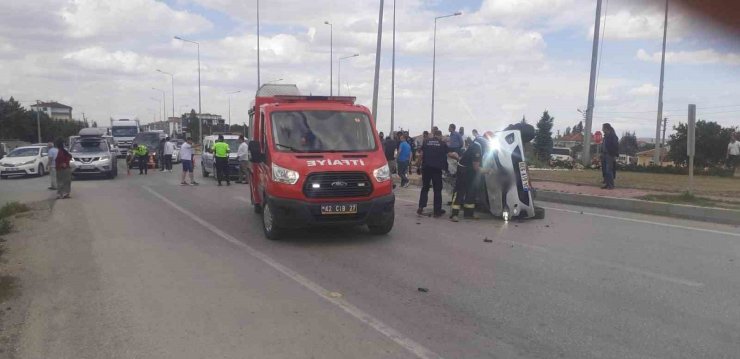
<box><xmin>272</xmin><ymin>111</ymin><xmax>377</xmax><ymax>152</ymax></box>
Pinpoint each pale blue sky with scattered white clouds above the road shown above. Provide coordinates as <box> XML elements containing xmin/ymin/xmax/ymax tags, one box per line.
<box><xmin>0</xmin><ymin>0</ymin><xmax>740</xmax><ymax>137</ymax></box>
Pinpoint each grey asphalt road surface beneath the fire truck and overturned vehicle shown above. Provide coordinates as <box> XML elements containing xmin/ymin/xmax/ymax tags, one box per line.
<box><xmin>0</xmin><ymin>161</ymin><xmax>740</xmax><ymax>358</ymax></box>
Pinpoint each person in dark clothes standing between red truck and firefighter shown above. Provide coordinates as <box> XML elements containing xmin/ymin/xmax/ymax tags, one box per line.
<box><xmin>416</xmin><ymin>130</ymin><xmax>447</xmax><ymax>217</ymax></box>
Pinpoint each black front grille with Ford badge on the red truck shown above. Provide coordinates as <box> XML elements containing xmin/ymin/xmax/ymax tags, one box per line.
<box><xmin>303</xmin><ymin>172</ymin><xmax>373</xmax><ymax>198</ymax></box>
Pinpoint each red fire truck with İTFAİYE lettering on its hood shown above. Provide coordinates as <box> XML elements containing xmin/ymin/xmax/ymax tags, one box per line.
<box><xmin>249</xmin><ymin>84</ymin><xmax>395</xmax><ymax>239</ymax></box>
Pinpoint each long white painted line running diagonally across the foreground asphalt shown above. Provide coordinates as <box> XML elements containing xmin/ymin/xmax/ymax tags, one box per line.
<box><xmin>144</xmin><ymin>186</ymin><xmax>442</xmax><ymax>359</ymax></box>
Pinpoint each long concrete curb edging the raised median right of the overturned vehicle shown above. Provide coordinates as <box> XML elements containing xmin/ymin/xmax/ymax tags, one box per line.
<box><xmin>536</xmin><ymin>190</ymin><xmax>740</xmax><ymax>225</ymax></box>
